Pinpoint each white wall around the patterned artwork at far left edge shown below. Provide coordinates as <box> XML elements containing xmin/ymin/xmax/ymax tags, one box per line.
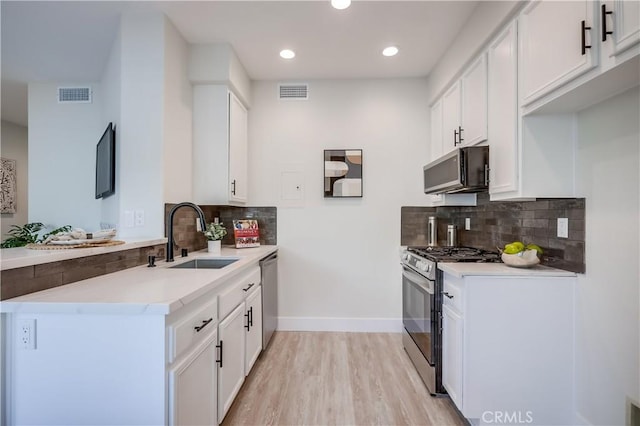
<box><xmin>0</xmin><ymin>120</ymin><xmax>29</xmax><ymax>240</ymax></box>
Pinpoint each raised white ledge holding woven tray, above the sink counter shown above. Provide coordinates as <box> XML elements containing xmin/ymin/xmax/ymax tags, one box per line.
<box><xmin>0</xmin><ymin>237</ymin><xmax>167</xmax><ymax>271</ymax></box>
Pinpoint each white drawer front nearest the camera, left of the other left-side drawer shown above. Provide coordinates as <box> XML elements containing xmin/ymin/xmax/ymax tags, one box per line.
<box><xmin>169</xmin><ymin>297</ymin><xmax>218</xmax><ymax>362</ymax></box>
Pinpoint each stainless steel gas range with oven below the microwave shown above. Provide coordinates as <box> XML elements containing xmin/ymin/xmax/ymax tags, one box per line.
<box><xmin>400</xmin><ymin>247</ymin><xmax>501</xmax><ymax>395</ymax></box>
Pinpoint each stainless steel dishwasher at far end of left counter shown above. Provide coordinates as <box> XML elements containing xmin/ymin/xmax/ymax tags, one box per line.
<box><xmin>260</xmin><ymin>251</ymin><xmax>278</xmax><ymax>349</ymax></box>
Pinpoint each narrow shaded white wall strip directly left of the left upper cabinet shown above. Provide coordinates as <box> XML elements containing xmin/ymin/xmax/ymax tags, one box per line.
<box><xmin>162</xmin><ymin>18</ymin><xmax>193</xmax><ymax>203</ymax></box>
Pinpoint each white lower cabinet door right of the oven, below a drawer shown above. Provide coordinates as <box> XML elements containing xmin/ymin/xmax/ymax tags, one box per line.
<box><xmin>442</xmin><ymin>305</ymin><xmax>464</xmax><ymax>410</ymax></box>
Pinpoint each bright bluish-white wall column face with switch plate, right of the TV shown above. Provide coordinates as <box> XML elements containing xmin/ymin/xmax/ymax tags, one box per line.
<box><xmin>118</xmin><ymin>13</ymin><xmax>165</xmax><ymax>237</ymax></box>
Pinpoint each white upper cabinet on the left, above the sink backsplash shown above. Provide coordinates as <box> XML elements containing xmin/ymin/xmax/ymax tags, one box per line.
<box><xmin>193</xmin><ymin>84</ymin><xmax>248</xmax><ymax>204</ymax></box>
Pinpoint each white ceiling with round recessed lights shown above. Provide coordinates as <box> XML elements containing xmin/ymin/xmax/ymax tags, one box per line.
<box><xmin>1</xmin><ymin>0</ymin><xmax>477</xmax><ymax>125</ymax></box>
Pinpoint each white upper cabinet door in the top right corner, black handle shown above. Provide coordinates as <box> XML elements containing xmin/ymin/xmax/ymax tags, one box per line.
<box><xmin>599</xmin><ymin>0</ymin><xmax>640</xmax><ymax>56</ymax></box>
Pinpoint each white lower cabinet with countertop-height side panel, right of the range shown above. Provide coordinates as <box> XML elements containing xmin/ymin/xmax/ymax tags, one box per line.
<box><xmin>442</xmin><ymin>273</ymin><xmax>576</xmax><ymax>425</ymax></box>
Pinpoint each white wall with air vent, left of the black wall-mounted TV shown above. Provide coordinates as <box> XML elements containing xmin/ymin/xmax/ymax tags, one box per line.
<box><xmin>28</xmin><ymin>82</ymin><xmax>106</xmax><ymax>231</ymax></box>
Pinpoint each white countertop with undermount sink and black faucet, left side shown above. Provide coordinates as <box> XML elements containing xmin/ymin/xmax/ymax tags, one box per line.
<box><xmin>0</xmin><ymin>246</ymin><xmax>278</xmax><ymax>315</ymax></box>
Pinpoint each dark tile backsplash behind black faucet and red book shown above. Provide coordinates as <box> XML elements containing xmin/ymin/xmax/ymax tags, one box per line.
<box><xmin>164</xmin><ymin>204</ymin><xmax>277</xmax><ymax>254</ymax></box>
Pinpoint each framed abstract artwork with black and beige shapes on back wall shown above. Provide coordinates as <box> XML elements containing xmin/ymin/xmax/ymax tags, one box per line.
<box><xmin>324</xmin><ymin>149</ymin><xmax>362</xmax><ymax>198</ymax></box>
